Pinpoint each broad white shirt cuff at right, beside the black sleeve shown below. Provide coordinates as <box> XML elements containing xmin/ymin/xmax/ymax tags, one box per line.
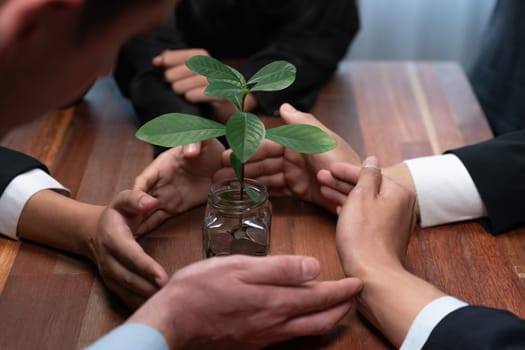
<box><xmin>404</xmin><ymin>154</ymin><xmax>487</xmax><ymax>227</ymax></box>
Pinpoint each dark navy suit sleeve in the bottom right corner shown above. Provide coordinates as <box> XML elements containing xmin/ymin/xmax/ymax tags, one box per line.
<box><xmin>423</xmin><ymin>306</ymin><xmax>525</xmax><ymax>350</ymax></box>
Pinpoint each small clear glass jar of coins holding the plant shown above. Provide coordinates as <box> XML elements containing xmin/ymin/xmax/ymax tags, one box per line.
<box><xmin>202</xmin><ymin>179</ymin><xmax>272</xmax><ymax>258</ymax></box>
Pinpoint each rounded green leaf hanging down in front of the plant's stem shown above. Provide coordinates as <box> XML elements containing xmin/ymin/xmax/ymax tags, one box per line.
<box><xmin>226</xmin><ymin>112</ymin><xmax>266</xmax><ymax>163</ymax></box>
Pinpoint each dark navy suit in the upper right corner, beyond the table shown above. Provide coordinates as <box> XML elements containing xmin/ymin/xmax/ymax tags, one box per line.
<box><xmin>469</xmin><ymin>0</ymin><xmax>525</xmax><ymax>135</ymax></box>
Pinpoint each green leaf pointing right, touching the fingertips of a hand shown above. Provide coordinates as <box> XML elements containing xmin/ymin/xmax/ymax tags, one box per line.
<box><xmin>266</xmin><ymin>124</ymin><xmax>337</xmax><ymax>154</ymax></box>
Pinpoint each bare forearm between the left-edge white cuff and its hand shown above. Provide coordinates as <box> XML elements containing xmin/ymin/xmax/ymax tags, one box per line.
<box><xmin>17</xmin><ymin>190</ymin><xmax>103</xmax><ymax>259</ymax></box>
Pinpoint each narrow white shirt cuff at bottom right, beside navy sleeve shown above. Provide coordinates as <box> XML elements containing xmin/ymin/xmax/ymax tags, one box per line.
<box><xmin>399</xmin><ymin>296</ymin><xmax>468</xmax><ymax>350</ymax></box>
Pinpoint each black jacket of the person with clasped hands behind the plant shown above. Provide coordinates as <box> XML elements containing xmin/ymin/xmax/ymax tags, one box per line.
<box><xmin>115</xmin><ymin>0</ymin><xmax>359</xmax><ymax>122</ymax></box>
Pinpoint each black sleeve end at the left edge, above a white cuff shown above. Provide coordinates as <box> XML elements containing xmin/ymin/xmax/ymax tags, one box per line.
<box><xmin>0</xmin><ymin>147</ymin><xmax>49</xmax><ymax>194</ymax></box>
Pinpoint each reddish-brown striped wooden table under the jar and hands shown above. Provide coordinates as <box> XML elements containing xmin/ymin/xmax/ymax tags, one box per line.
<box><xmin>0</xmin><ymin>62</ymin><xmax>525</xmax><ymax>350</ymax></box>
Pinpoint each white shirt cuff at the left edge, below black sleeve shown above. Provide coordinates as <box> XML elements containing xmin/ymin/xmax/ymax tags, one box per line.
<box><xmin>0</xmin><ymin>169</ymin><xmax>69</xmax><ymax>239</ymax></box>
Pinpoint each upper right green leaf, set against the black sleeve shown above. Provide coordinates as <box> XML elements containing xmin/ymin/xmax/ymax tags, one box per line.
<box><xmin>248</xmin><ymin>61</ymin><xmax>297</xmax><ymax>91</ymax></box>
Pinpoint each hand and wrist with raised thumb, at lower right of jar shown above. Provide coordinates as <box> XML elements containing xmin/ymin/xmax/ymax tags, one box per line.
<box><xmin>336</xmin><ymin>157</ymin><xmax>445</xmax><ymax>348</ymax></box>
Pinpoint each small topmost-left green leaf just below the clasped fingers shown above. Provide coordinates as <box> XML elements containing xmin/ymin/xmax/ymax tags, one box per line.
<box><xmin>185</xmin><ymin>56</ymin><xmax>246</xmax><ymax>87</ymax></box>
